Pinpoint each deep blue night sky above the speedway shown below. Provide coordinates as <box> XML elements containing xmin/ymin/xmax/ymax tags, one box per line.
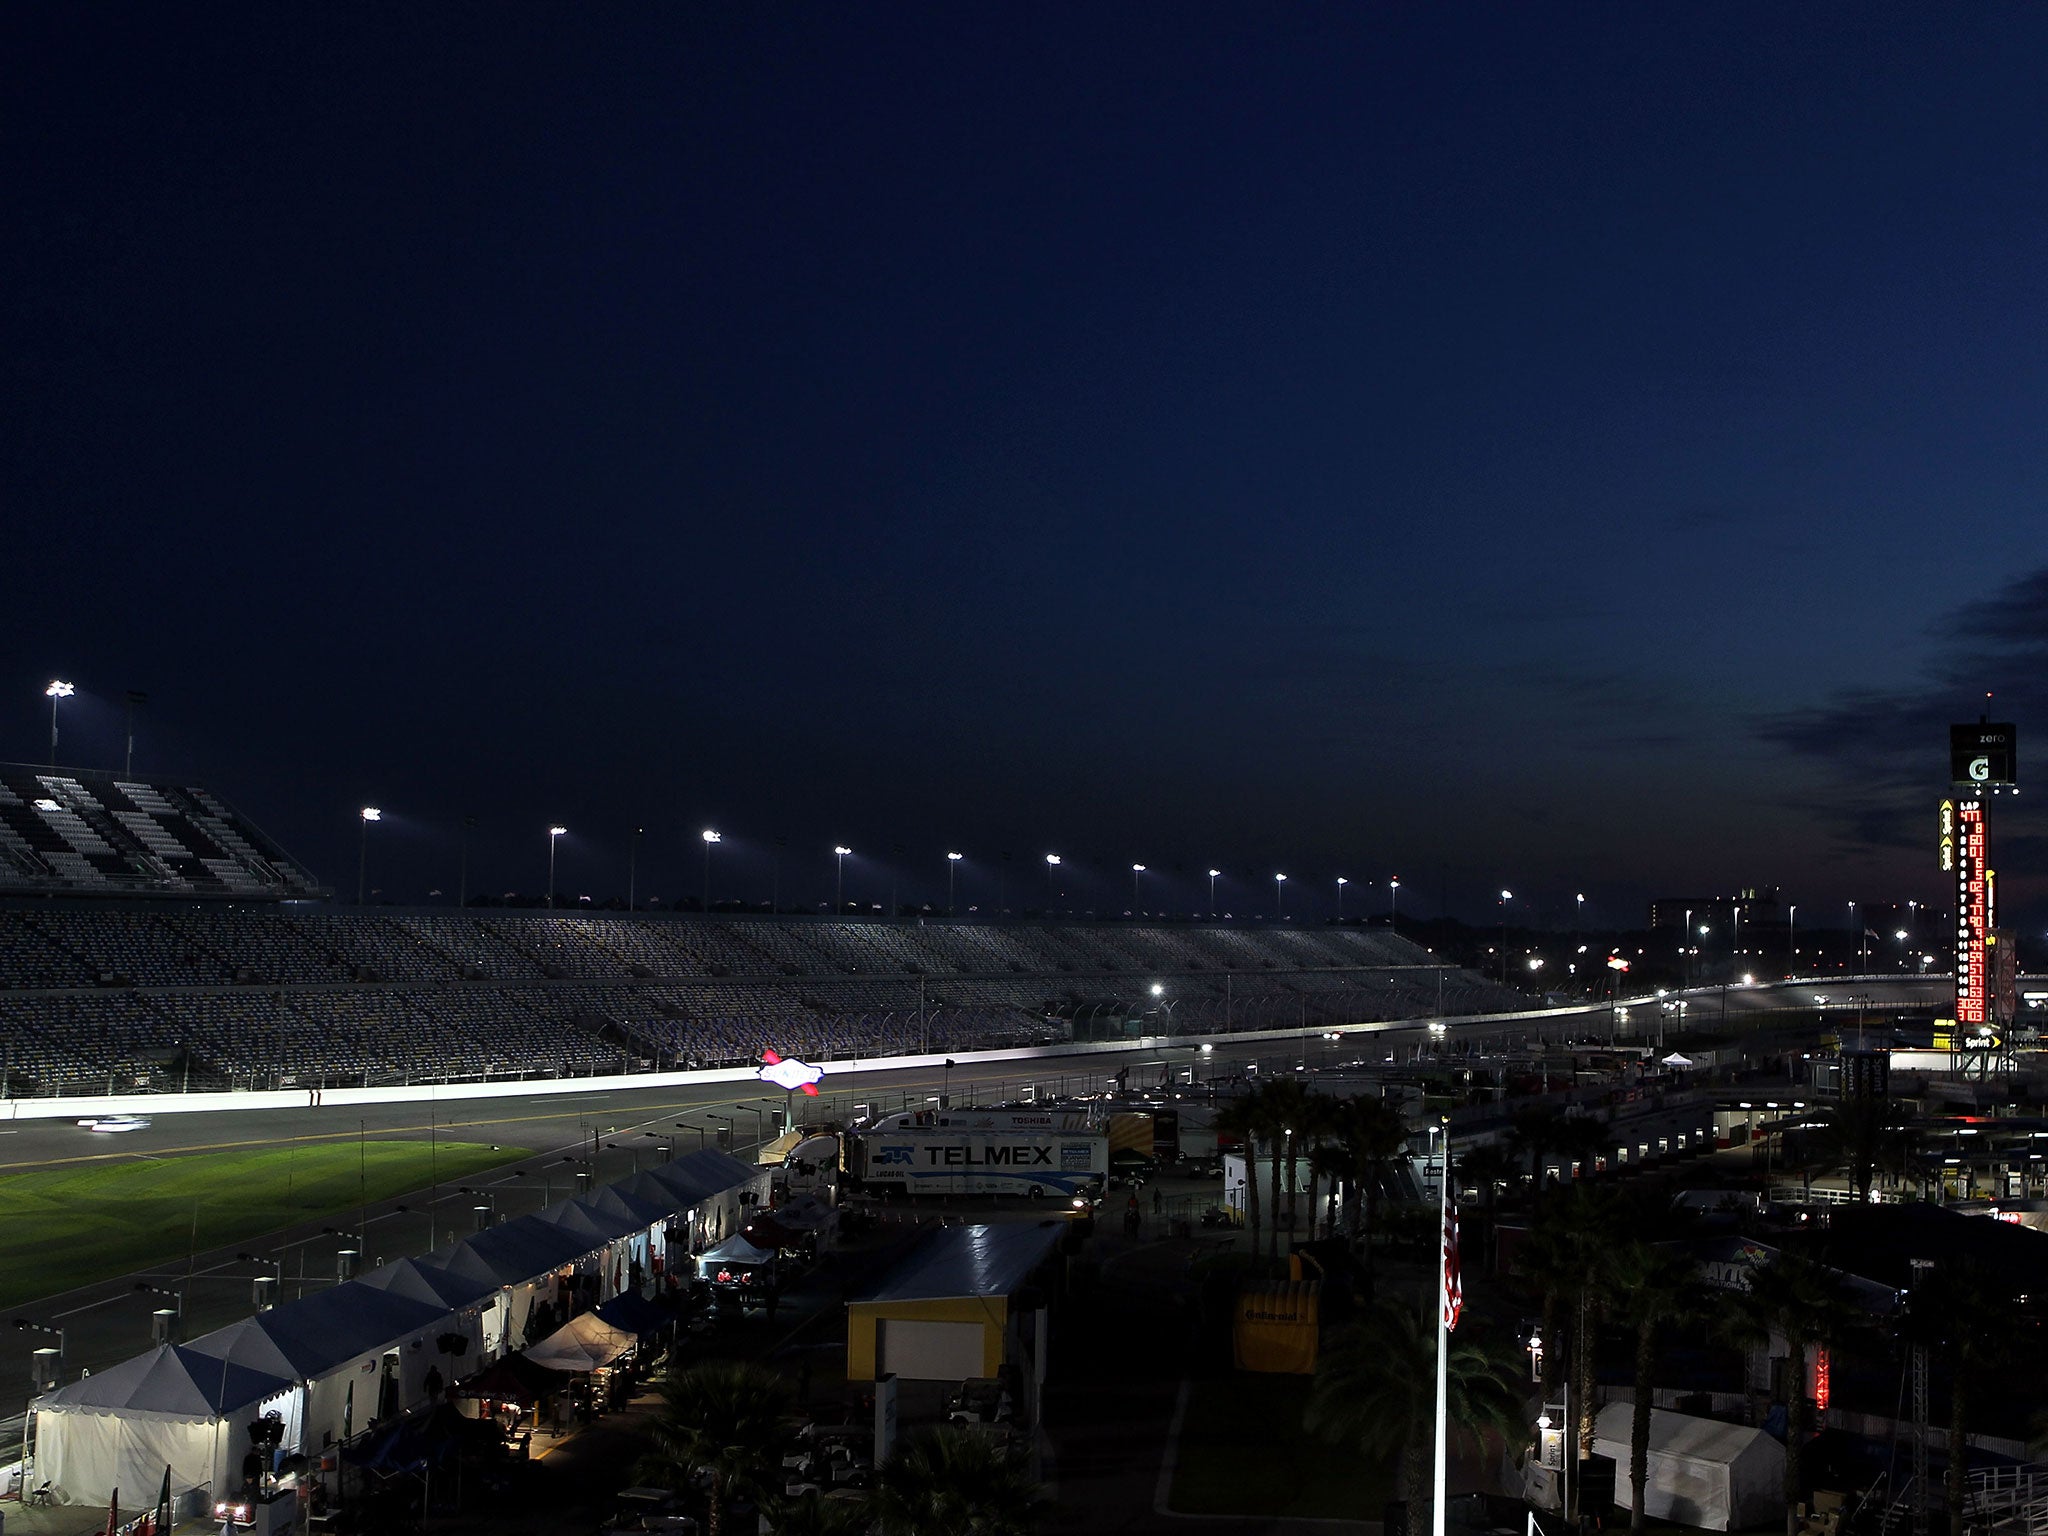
<box><xmin>0</xmin><ymin>0</ymin><xmax>2048</xmax><ymax>924</ymax></box>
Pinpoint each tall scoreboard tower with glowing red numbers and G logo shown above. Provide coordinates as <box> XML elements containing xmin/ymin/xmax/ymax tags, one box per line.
<box><xmin>1939</xmin><ymin>719</ymin><xmax>2019</xmax><ymax>1077</ymax></box>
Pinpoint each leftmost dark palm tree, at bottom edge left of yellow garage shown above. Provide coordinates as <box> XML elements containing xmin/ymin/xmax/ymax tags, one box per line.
<box><xmin>635</xmin><ymin>1360</ymin><xmax>791</xmax><ymax>1536</ymax></box>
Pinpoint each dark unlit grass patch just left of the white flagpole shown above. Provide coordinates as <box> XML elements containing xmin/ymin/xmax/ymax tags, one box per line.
<box><xmin>1169</xmin><ymin>1370</ymin><xmax>1393</xmax><ymax>1520</ymax></box>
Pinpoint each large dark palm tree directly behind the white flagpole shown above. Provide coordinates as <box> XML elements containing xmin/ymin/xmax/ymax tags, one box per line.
<box><xmin>1303</xmin><ymin>1300</ymin><xmax>1528</xmax><ymax>1505</ymax></box>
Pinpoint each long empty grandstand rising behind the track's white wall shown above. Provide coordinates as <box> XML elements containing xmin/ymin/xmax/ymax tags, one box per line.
<box><xmin>0</xmin><ymin>766</ymin><xmax>1526</xmax><ymax>1098</ymax></box>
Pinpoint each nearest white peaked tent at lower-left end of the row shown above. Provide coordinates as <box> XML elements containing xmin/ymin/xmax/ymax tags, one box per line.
<box><xmin>33</xmin><ymin>1343</ymin><xmax>299</xmax><ymax>1505</ymax></box>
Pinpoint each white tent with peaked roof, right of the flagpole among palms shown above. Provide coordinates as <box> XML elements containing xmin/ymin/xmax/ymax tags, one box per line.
<box><xmin>1593</xmin><ymin>1403</ymin><xmax>1786</xmax><ymax>1530</ymax></box>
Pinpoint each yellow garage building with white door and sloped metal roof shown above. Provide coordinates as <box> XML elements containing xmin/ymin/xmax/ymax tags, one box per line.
<box><xmin>846</xmin><ymin>1221</ymin><xmax>1067</xmax><ymax>1382</ymax></box>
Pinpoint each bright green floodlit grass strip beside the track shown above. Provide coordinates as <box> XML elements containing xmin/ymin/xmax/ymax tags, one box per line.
<box><xmin>0</xmin><ymin>1139</ymin><xmax>526</xmax><ymax>1309</ymax></box>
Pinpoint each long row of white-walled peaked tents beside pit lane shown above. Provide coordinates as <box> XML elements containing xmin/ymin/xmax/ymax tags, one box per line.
<box><xmin>29</xmin><ymin>1147</ymin><xmax>768</xmax><ymax>1505</ymax></box>
